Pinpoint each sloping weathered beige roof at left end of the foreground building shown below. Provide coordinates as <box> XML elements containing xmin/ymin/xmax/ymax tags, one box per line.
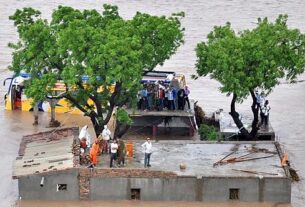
<box><xmin>13</xmin><ymin>129</ymin><xmax>74</xmax><ymax>178</ymax></box>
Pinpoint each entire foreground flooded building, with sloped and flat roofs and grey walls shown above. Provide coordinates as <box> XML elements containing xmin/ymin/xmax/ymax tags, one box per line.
<box><xmin>13</xmin><ymin>128</ymin><xmax>291</xmax><ymax>203</ymax></box>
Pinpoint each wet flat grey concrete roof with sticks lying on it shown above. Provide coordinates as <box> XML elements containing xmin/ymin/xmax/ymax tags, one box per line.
<box><xmin>99</xmin><ymin>141</ymin><xmax>286</xmax><ymax>177</ymax></box>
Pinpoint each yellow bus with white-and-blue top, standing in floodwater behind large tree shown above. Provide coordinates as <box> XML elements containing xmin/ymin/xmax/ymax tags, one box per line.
<box><xmin>3</xmin><ymin>71</ymin><xmax>185</xmax><ymax>114</ymax></box>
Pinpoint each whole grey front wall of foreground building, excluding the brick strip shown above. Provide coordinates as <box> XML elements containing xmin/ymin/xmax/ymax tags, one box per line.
<box><xmin>19</xmin><ymin>169</ymin><xmax>291</xmax><ymax>203</ymax></box>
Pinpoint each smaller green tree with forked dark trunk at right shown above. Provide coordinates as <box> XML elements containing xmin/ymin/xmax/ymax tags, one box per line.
<box><xmin>194</xmin><ymin>15</ymin><xmax>305</xmax><ymax>139</ymax></box>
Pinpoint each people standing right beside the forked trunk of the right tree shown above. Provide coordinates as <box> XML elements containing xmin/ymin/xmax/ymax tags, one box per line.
<box><xmin>255</xmin><ymin>90</ymin><xmax>271</xmax><ymax>128</ymax></box>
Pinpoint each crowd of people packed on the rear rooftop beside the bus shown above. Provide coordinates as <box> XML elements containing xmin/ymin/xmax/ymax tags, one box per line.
<box><xmin>138</xmin><ymin>82</ymin><xmax>191</xmax><ymax>111</ymax></box>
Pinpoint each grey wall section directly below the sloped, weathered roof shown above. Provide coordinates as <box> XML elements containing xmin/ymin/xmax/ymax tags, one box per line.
<box><xmin>18</xmin><ymin>169</ymin><xmax>79</xmax><ymax>200</ymax></box>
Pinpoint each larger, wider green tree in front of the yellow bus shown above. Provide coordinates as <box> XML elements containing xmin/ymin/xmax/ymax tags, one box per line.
<box><xmin>9</xmin><ymin>5</ymin><xmax>184</xmax><ymax>135</ymax></box>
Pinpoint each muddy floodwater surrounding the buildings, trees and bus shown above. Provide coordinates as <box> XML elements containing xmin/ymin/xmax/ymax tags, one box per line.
<box><xmin>0</xmin><ymin>0</ymin><xmax>305</xmax><ymax>207</ymax></box>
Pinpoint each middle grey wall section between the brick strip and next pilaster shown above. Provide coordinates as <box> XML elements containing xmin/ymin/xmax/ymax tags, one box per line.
<box><xmin>90</xmin><ymin>177</ymin><xmax>197</xmax><ymax>201</ymax></box>
